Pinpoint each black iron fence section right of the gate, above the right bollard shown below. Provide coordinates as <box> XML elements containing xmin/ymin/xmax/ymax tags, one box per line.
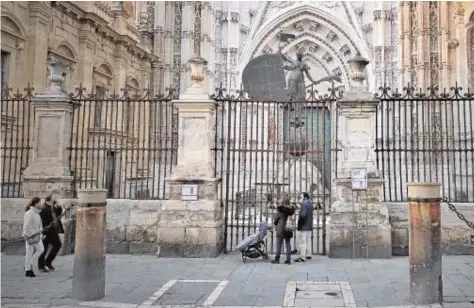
<box><xmin>375</xmin><ymin>85</ymin><xmax>474</xmax><ymax>202</ymax></box>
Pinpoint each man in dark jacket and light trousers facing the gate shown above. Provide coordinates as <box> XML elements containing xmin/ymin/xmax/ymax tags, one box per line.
<box><xmin>295</xmin><ymin>193</ymin><xmax>313</xmax><ymax>262</ymax></box>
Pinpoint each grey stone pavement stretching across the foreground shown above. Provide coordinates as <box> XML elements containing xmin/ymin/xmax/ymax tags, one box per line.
<box><xmin>1</xmin><ymin>254</ymin><xmax>474</xmax><ymax>308</ymax></box>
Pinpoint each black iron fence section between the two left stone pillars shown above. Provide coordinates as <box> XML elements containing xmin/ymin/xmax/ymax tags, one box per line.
<box><xmin>69</xmin><ymin>88</ymin><xmax>178</xmax><ymax>199</ymax></box>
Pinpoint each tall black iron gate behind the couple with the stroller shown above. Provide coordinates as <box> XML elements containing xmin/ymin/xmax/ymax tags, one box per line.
<box><xmin>213</xmin><ymin>85</ymin><xmax>338</xmax><ymax>254</ymax></box>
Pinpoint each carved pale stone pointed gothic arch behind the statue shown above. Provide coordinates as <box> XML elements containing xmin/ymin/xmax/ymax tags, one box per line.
<box><xmin>239</xmin><ymin>3</ymin><xmax>375</xmax><ymax>89</ymax></box>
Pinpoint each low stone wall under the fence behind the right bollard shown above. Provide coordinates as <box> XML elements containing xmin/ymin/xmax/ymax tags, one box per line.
<box><xmin>387</xmin><ymin>202</ymin><xmax>474</xmax><ymax>256</ymax></box>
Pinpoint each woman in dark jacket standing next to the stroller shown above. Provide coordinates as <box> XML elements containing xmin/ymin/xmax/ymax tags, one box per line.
<box><xmin>272</xmin><ymin>198</ymin><xmax>295</xmax><ymax>264</ymax></box>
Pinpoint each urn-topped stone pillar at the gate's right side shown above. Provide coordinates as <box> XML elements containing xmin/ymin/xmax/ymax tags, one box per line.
<box><xmin>329</xmin><ymin>55</ymin><xmax>392</xmax><ymax>258</ymax></box>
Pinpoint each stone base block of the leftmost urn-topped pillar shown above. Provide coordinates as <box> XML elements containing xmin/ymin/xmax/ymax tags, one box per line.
<box><xmin>23</xmin><ymin>176</ymin><xmax>74</xmax><ymax>199</ymax></box>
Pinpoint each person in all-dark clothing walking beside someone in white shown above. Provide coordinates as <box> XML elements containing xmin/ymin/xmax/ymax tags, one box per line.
<box><xmin>38</xmin><ymin>196</ymin><xmax>64</xmax><ymax>272</ymax></box>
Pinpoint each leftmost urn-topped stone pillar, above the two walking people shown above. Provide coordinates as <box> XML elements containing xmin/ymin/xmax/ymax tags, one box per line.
<box><xmin>23</xmin><ymin>58</ymin><xmax>78</xmax><ymax>199</ymax></box>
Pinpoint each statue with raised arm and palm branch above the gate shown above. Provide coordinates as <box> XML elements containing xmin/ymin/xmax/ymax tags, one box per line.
<box><xmin>278</xmin><ymin>32</ymin><xmax>341</xmax><ymax>101</ymax></box>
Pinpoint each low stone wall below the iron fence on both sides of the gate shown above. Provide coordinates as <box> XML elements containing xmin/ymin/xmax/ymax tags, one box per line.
<box><xmin>1</xmin><ymin>199</ymin><xmax>474</xmax><ymax>255</ymax></box>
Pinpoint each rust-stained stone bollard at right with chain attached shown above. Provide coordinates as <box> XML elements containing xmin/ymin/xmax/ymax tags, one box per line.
<box><xmin>408</xmin><ymin>182</ymin><xmax>443</xmax><ymax>305</ymax></box>
